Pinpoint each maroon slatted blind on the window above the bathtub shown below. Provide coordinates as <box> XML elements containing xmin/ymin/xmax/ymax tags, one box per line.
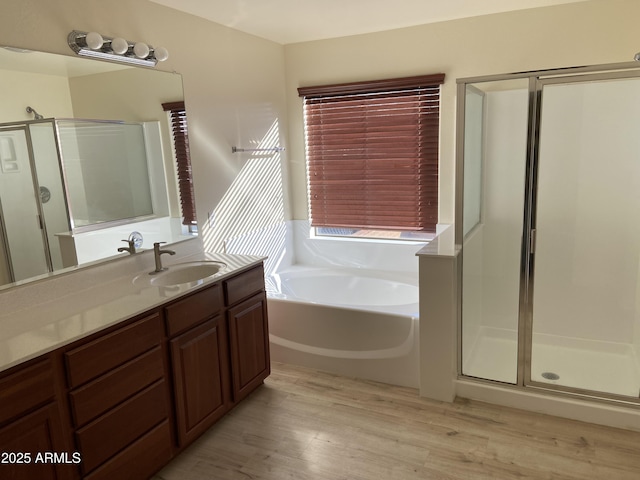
<box><xmin>298</xmin><ymin>74</ymin><xmax>444</xmax><ymax>232</ymax></box>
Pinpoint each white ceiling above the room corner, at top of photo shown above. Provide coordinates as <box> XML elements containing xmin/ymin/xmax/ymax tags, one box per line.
<box><xmin>151</xmin><ymin>0</ymin><xmax>587</xmax><ymax>44</ymax></box>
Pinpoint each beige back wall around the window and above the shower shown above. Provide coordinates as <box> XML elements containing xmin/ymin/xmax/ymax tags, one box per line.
<box><xmin>285</xmin><ymin>0</ymin><xmax>640</xmax><ymax>223</ymax></box>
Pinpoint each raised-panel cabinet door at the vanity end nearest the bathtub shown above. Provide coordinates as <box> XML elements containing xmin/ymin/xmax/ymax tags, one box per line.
<box><xmin>228</xmin><ymin>293</ymin><xmax>271</xmax><ymax>402</ymax></box>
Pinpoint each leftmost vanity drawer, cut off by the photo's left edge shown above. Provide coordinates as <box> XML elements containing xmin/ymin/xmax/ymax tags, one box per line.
<box><xmin>0</xmin><ymin>358</ymin><xmax>54</xmax><ymax>423</ymax></box>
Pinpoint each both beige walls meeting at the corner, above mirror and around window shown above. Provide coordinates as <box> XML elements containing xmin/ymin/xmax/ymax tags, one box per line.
<box><xmin>0</xmin><ymin>0</ymin><xmax>640</xmax><ymax>256</ymax></box>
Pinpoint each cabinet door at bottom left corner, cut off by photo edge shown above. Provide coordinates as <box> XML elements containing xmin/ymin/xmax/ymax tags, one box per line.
<box><xmin>0</xmin><ymin>403</ymin><xmax>75</xmax><ymax>480</ymax></box>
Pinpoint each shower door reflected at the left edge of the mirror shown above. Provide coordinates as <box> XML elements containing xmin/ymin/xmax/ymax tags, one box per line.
<box><xmin>0</xmin><ymin>127</ymin><xmax>49</xmax><ymax>281</ymax></box>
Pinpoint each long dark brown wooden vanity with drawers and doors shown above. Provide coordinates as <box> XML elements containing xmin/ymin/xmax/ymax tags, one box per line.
<box><xmin>0</xmin><ymin>260</ymin><xmax>270</xmax><ymax>480</ymax></box>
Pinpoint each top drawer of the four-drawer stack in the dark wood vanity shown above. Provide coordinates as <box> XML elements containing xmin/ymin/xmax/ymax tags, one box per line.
<box><xmin>65</xmin><ymin>313</ymin><xmax>163</xmax><ymax>387</ymax></box>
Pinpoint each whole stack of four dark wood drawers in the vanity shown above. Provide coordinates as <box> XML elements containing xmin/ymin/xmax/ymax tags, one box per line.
<box><xmin>64</xmin><ymin>312</ymin><xmax>173</xmax><ymax>480</ymax></box>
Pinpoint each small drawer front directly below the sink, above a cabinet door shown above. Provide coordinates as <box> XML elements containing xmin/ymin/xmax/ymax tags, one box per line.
<box><xmin>165</xmin><ymin>283</ymin><xmax>224</xmax><ymax>336</ymax></box>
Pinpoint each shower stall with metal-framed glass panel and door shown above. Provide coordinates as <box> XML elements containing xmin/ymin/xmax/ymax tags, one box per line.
<box><xmin>456</xmin><ymin>62</ymin><xmax>640</xmax><ymax>404</ymax></box>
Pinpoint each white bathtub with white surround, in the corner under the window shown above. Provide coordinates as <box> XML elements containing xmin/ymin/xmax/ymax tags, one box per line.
<box><xmin>225</xmin><ymin>220</ymin><xmax>424</xmax><ymax>388</ymax></box>
